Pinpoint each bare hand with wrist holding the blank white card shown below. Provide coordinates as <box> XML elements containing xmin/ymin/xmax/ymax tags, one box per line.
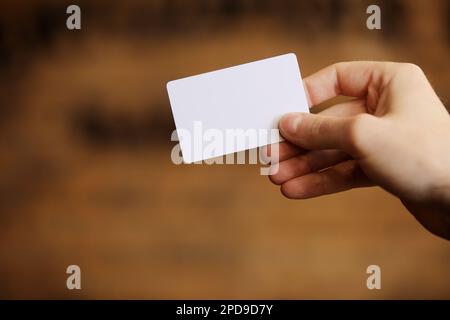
<box><xmin>268</xmin><ymin>62</ymin><xmax>450</xmax><ymax>239</ymax></box>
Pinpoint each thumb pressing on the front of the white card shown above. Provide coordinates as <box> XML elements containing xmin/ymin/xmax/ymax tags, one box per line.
<box><xmin>279</xmin><ymin>113</ymin><xmax>369</xmax><ymax>156</ymax></box>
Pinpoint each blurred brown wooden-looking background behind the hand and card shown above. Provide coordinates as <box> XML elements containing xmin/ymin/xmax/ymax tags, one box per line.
<box><xmin>0</xmin><ymin>0</ymin><xmax>450</xmax><ymax>299</ymax></box>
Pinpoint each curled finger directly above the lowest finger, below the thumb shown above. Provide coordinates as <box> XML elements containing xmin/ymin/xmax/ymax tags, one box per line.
<box><xmin>269</xmin><ymin>150</ymin><xmax>349</xmax><ymax>185</ymax></box>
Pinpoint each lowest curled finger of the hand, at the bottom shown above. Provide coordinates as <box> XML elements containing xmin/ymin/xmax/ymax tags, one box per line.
<box><xmin>281</xmin><ymin>160</ymin><xmax>372</xmax><ymax>199</ymax></box>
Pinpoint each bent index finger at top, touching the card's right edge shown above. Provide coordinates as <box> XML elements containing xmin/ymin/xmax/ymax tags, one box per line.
<box><xmin>303</xmin><ymin>61</ymin><xmax>393</xmax><ymax>106</ymax></box>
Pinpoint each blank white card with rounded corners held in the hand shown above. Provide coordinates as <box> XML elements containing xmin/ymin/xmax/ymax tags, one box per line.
<box><xmin>167</xmin><ymin>53</ymin><xmax>309</xmax><ymax>163</ymax></box>
